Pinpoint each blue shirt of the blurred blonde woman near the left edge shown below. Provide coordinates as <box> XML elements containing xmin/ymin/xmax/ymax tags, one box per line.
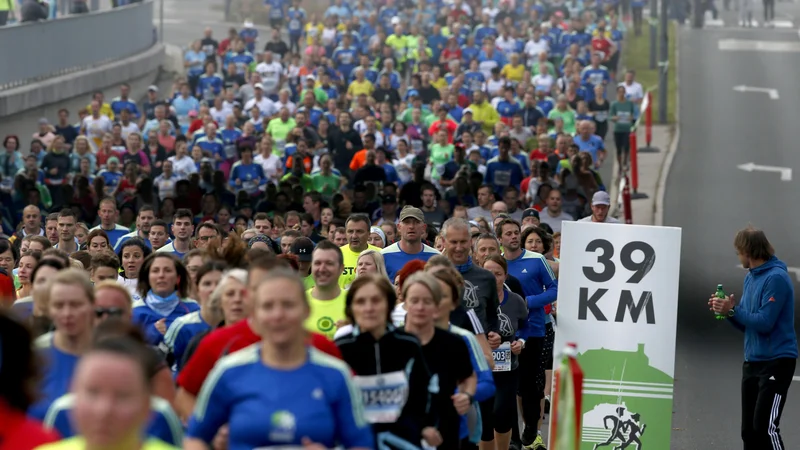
<box><xmin>28</xmin><ymin>333</ymin><xmax>80</xmax><ymax>421</ymax></box>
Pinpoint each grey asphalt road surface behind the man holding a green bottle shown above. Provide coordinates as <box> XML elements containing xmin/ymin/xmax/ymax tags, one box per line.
<box><xmin>664</xmin><ymin>20</ymin><xmax>800</xmax><ymax>450</ymax></box>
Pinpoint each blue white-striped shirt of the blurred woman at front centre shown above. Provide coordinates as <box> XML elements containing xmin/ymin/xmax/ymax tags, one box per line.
<box><xmin>187</xmin><ymin>344</ymin><xmax>375</xmax><ymax>450</ymax></box>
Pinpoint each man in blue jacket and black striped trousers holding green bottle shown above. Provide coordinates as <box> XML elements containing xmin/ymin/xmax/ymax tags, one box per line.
<box><xmin>708</xmin><ymin>227</ymin><xmax>797</xmax><ymax>450</ymax></box>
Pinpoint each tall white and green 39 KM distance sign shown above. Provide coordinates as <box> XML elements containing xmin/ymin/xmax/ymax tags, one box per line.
<box><xmin>548</xmin><ymin>222</ymin><xmax>681</xmax><ymax>450</ymax></box>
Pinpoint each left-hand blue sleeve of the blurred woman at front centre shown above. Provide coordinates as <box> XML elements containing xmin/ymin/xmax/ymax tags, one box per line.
<box><xmin>186</xmin><ymin>366</ymin><xmax>232</xmax><ymax>443</ymax></box>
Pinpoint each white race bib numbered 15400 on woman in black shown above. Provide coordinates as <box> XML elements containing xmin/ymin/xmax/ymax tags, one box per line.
<box><xmin>353</xmin><ymin>371</ymin><xmax>408</xmax><ymax>423</ymax></box>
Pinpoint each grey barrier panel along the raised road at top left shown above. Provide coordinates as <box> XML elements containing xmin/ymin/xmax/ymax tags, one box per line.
<box><xmin>0</xmin><ymin>0</ymin><xmax>156</xmax><ymax>91</ymax></box>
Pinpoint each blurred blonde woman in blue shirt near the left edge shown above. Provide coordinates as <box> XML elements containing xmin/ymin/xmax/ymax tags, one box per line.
<box><xmin>28</xmin><ymin>269</ymin><xmax>95</xmax><ymax>420</ymax></box>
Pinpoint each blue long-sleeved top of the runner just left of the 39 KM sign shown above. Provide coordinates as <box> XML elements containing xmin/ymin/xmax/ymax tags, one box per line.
<box><xmin>506</xmin><ymin>250</ymin><xmax>558</xmax><ymax>339</ymax></box>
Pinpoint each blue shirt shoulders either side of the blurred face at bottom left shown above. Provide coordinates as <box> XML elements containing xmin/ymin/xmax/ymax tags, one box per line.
<box><xmin>42</xmin><ymin>394</ymin><xmax>183</xmax><ymax>446</ymax></box>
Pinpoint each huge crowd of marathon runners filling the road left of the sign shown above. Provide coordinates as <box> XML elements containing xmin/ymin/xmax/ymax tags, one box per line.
<box><xmin>0</xmin><ymin>0</ymin><xmax>643</xmax><ymax>450</ymax></box>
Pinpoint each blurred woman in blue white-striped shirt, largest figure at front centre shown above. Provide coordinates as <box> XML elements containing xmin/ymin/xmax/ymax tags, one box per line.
<box><xmin>183</xmin><ymin>269</ymin><xmax>374</xmax><ymax>450</ymax></box>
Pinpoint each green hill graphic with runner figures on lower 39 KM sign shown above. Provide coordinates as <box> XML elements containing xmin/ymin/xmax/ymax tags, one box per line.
<box><xmin>578</xmin><ymin>344</ymin><xmax>673</xmax><ymax>450</ymax></box>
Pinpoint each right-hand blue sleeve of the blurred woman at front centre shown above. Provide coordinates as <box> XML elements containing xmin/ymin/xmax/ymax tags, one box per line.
<box><xmin>332</xmin><ymin>371</ymin><xmax>375</xmax><ymax>449</ymax></box>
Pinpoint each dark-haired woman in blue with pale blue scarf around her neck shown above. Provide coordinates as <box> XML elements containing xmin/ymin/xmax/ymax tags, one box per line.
<box><xmin>132</xmin><ymin>255</ymin><xmax>200</xmax><ymax>345</ymax></box>
